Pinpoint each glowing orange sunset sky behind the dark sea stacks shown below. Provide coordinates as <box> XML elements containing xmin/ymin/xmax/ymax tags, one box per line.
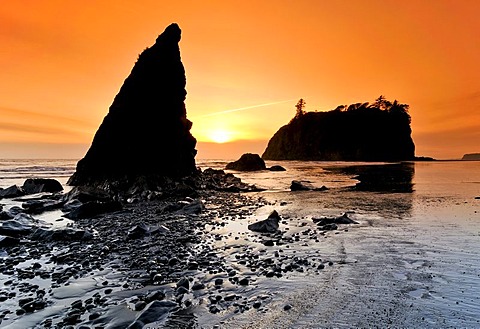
<box><xmin>0</xmin><ymin>0</ymin><xmax>480</xmax><ymax>159</ymax></box>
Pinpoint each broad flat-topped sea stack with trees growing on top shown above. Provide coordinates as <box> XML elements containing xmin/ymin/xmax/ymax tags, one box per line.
<box><xmin>262</xmin><ymin>96</ymin><xmax>415</xmax><ymax>161</ymax></box>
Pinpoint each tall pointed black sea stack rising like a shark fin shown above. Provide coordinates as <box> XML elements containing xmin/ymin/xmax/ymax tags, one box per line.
<box><xmin>68</xmin><ymin>24</ymin><xmax>196</xmax><ymax>185</ymax></box>
